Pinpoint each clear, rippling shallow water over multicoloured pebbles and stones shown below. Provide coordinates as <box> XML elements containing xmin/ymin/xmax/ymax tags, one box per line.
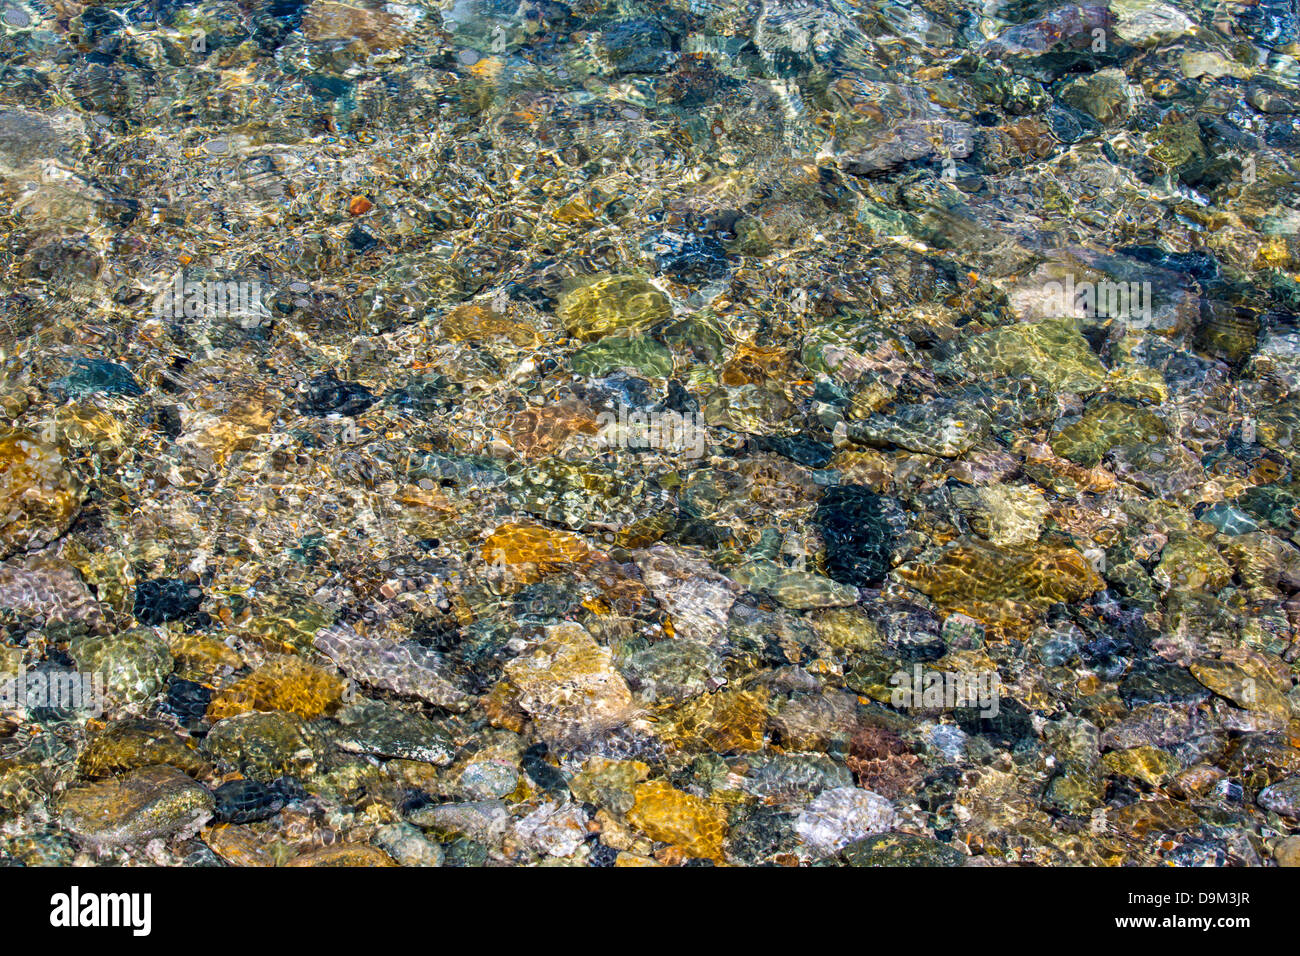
<box><xmin>0</xmin><ymin>0</ymin><xmax>1300</xmax><ymax>865</ymax></box>
